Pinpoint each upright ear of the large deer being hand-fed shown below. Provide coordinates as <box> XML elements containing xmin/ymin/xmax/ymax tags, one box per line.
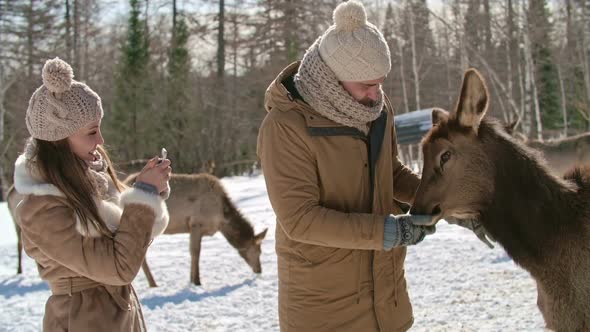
<box><xmin>455</xmin><ymin>69</ymin><xmax>489</xmax><ymax>133</ymax></box>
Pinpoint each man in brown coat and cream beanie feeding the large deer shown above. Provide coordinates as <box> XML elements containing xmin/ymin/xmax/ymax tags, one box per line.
<box><xmin>258</xmin><ymin>1</ymin><xmax>433</xmax><ymax>332</ymax></box>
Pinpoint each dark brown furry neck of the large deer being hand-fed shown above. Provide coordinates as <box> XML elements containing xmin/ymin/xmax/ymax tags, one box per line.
<box><xmin>481</xmin><ymin>131</ymin><xmax>574</xmax><ymax>271</ymax></box>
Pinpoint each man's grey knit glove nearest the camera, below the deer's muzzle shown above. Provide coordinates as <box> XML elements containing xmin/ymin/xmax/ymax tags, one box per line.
<box><xmin>383</xmin><ymin>214</ymin><xmax>436</xmax><ymax>250</ymax></box>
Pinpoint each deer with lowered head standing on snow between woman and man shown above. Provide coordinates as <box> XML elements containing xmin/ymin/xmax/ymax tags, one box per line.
<box><xmin>124</xmin><ymin>174</ymin><xmax>267</xmax><ymax>287</ymax></box>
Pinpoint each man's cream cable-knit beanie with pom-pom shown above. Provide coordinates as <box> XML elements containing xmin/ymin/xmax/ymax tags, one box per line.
<box><xmin>319</xmin><ymin>0</ymin><xmax>391</xmax><ymax>82</ymax></box>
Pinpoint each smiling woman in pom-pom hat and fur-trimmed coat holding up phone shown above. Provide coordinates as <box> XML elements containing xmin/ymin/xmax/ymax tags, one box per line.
<box><xmin>14</xmin><ymin>58</ymin><xmax>171</xmax><ymax>331</ymax></box>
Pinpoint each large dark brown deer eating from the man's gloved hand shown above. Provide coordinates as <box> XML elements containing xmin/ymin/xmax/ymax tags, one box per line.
<box><xmin>411</xmin><ymin>69</ymin><xmax>590</xmax><ymax>331</ymax></box>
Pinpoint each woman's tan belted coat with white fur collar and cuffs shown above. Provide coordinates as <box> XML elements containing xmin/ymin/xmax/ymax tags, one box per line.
<box><xmin>14</xmin><ymin>155</ymin><xmax>169</xmax><ymax>331</ymax></box>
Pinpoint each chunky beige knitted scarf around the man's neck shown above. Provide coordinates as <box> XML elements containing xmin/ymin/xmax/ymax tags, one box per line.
<box><xmin>294</xmin><ymin>37</ymin><xmax>383</xmax><ymax>134</ymax></box>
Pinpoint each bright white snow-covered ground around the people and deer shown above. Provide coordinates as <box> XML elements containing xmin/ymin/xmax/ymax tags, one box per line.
<box><xmin>0</xmin><ymin>176</ymin><xmax>543</xmax><ymax>331</ymax></box>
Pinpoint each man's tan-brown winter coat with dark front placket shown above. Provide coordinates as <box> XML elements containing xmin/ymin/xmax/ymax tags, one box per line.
<box><xmin>258</xmin><ymin>63</ymin><xmax>419</xmax><ymax>332</ymax></box>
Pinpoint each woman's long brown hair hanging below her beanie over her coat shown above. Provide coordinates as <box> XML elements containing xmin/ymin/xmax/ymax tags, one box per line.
<box><xmin>34</xmin><ymin>138</ymin><xmax>124</xmax><ymax>237</ymax></box>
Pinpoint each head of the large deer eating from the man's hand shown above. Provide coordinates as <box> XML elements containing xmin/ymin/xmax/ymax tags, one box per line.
<box><xmin>410</xmin><ymin>69</ymin><xmax>494</xmax><ymax>224</ymax></box>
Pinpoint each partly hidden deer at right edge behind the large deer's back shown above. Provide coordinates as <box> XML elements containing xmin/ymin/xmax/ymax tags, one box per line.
<box><xmin>506</xmin><ymin>121</ymin><xmax>590</xmax><ymax>175</ymax></box>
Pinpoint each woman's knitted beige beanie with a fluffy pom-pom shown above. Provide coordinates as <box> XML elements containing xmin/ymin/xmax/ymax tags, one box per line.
<box><xmin>26</xmin><ymin>58</ymin><xmax>103</xmax><ymax>141</ymax></box>
